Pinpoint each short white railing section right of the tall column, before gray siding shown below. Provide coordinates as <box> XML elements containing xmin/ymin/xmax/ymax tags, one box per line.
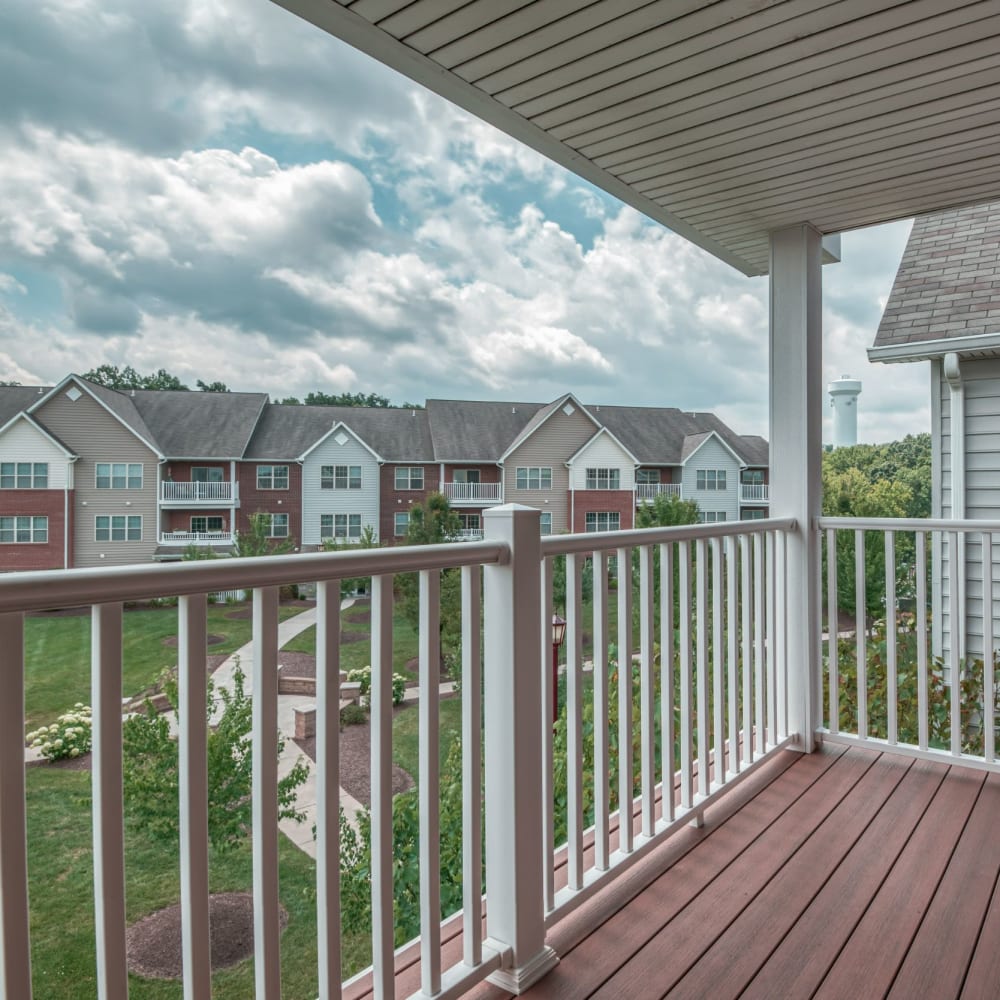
<box><xmin>818</xmin><ymin>517</ymin><xmax>1000</xmax><ymax>770</ymax></box>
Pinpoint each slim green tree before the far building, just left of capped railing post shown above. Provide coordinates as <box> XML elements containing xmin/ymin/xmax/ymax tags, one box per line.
<box><xmin>396</xmin><ymin>493</ymin><xmax>462</xmax><ymax>671</ymax></box>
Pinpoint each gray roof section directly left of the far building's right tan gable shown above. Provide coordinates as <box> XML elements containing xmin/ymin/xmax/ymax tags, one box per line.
<box><xmin>427</xmin><ymin>399</ymin><xmax>548</xmax><ymax>462</ymax></box>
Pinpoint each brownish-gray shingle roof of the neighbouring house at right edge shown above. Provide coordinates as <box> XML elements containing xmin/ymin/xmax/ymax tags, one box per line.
<box><xmin>874</xmin><ymin>202</ymin><xmax>1000</xmax><ymax>347</ymax></box>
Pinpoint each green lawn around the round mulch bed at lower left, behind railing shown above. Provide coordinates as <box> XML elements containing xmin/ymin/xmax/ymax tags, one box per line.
<box><xmin>27</xmin><ymin>768</ymin><xmax>371</xmax><ymax>1000</ymax></box>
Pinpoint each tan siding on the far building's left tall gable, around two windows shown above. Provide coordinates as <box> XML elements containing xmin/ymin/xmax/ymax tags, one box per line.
<box><xmin>35</xmin><ymin>389</ymin><xmax>159</xmax><ymax>566</ymax></box>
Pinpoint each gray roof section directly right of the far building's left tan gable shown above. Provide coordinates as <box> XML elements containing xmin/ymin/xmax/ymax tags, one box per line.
<box><xmin>129</xmin><ymin>389</ymin><xmax>267</xmax><ymax>458</ymax></box>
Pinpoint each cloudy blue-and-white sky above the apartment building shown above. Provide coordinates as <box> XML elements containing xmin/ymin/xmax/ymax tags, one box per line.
<box><xmin>0</xmin><ymin>0</ymin><xmax>930</xmax><ymax>442</ymax></box>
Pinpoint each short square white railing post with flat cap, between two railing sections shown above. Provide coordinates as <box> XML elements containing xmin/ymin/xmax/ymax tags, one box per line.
<box><xmin>483</xmin><ymin>504</ymin><xmax>558</xmax><ymax>993</ymax></box>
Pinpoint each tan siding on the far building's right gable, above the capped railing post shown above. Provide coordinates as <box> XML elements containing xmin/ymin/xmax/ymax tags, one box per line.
<box><xmin>503</xmin><ymin>404</ymin><xmax>597</xmax><ymax>535</ymax></box>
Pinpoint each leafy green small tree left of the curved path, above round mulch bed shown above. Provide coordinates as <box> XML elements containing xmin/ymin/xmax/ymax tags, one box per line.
<box><xmin>122</xmin><ymin>664</ymin><xmax>309</xmax><ymax>851</ymax></box>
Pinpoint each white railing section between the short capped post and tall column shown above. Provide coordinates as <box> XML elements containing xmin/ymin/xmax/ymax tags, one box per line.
<box><xmin>541</xmin><ymin>520</ymin><xmax>795</xmax><ymax>922</ymax></box>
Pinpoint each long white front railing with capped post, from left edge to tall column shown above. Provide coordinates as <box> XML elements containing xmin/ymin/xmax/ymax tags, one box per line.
<box><xmin>0</xmin><ymin>506</ymin><xmax>794</xmax><ymax>1000</ymax></box>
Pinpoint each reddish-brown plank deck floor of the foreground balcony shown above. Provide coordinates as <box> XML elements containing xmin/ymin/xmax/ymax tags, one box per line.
<box><xmin>462</xmin><ymin>747</ymin><xmax>1000</xmax><ymax>1000</ymax></box>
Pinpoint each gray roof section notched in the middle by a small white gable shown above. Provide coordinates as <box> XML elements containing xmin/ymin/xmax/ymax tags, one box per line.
<box><xmin>245</xmin><ymin>403</ymin><xmax>435</xmax><ymax>462</ymax></box>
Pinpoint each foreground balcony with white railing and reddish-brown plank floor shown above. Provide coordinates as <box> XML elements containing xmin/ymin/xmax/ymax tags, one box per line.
<box><xmin>0</xmin><ymin>507</ymin><xmax>1000</xmax><ymax>1000</ymax></box>
